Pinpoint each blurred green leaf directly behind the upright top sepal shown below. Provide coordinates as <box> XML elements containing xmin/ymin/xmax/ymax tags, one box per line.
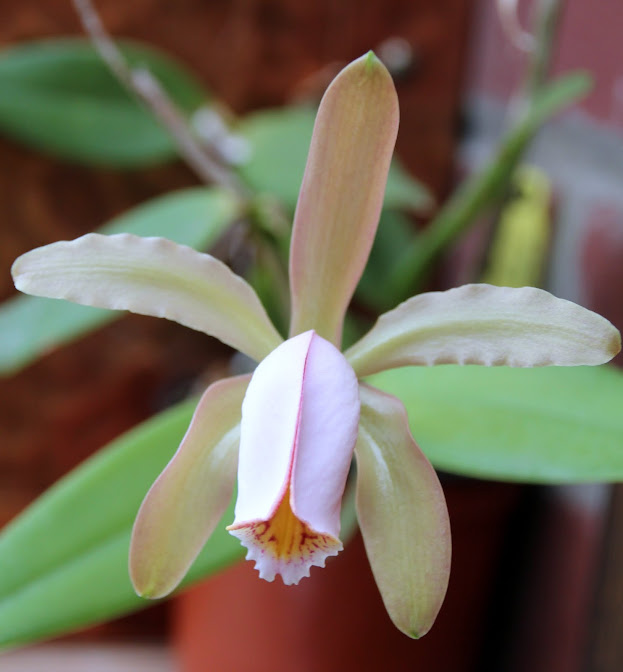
<box><xmin>236</xmin><ymin>107</ymin><xmax>432</xmax><ymax>211</ymax></box>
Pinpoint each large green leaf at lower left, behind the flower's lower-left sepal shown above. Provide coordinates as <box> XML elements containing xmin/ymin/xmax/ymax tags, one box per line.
<box><xmin>0</xmin><ymin>400</ymin><xmax>244</xmax><ymax>647</ymax></box>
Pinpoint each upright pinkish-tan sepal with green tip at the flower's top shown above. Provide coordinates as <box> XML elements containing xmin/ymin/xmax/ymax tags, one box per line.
<box><xmin>290</xmin><ymin>52</ymin><xmax>398</xmax><ymax>347</ymax></box>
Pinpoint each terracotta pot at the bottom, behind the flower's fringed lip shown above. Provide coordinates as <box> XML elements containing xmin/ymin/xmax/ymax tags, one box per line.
<box><xmin>173</xmin><ymin>481</ymin><xmax>519</xmax><ymax>672</ymax></box>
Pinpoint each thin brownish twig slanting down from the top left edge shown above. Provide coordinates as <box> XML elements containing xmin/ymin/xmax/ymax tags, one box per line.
<box><xmin>73</xmin><ymin>0</ymin><xmax>249</xmax><ymax>201</ymax></box>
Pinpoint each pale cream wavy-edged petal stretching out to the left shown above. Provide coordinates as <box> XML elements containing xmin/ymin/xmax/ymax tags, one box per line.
<box><xmin>12</xmin><ymin>233</ymin><xmax>283</xmax><ymax>361</ymax></box>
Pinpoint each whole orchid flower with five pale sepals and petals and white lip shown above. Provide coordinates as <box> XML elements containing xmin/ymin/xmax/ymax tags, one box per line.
<box><xmin>13</xmin><ymin>54</ymin><xmax>620</xmax><ymax>637</ymax></box>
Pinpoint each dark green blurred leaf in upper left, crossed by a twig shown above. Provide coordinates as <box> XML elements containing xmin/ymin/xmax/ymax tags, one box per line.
<box><xmin>0</xmin><ymin>39</ymin><xmax>206</xmax><ymax>168</ymax></box>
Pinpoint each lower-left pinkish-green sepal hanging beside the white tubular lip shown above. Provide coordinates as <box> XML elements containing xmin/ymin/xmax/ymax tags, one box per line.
<box><xmin>129</xmin><ymin>375</ymin><xmax>251</xmax><ymax>598</ymax></box>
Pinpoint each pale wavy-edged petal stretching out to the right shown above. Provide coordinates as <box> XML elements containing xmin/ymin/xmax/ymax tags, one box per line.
<box><xmin>345</xmin><ymin>284</ymin><xmax>621</xmax><ymax>377</ymax></box>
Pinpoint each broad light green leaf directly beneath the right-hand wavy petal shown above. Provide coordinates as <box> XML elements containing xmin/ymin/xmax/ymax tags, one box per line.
<box><xmin>370</xmin><ymin>366</ymin><xmax>623</xmax><ymax>483</ymax></box>
